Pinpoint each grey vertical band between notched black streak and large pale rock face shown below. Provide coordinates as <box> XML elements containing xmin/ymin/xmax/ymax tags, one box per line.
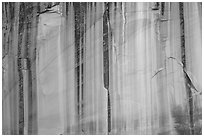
<box><xmin>28</xmin><ymin>3</ymin><xmax>39</xmax><ymax>134</ymax></box>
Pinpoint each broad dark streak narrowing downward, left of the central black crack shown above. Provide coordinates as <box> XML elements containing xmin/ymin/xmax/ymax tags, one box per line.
<box><xmin>74</xmin><ymin>2</ymin><xmax>86</xmax><ymax>133</ymax></box>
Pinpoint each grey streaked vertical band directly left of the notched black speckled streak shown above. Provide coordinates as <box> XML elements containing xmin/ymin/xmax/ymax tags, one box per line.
<box><xmin>7</xmin><ymin>3</ymin><xmax>20</xmax><ymax>134</ymax></box>
